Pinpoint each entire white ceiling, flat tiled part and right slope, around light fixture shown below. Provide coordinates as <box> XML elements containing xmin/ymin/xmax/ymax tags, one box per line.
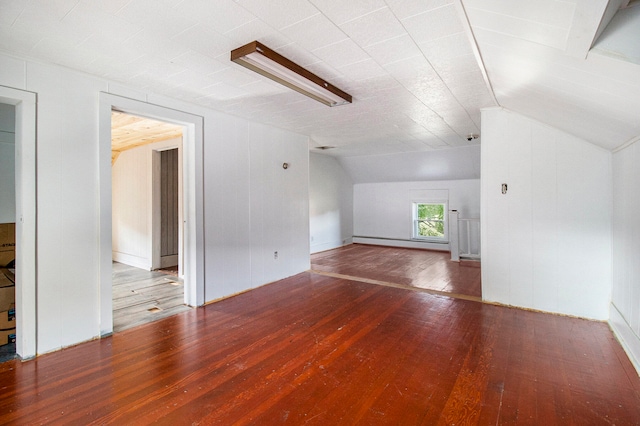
<box><xmin>0</xmin><ymin>0</ymin><xmax>640</xmax><ymax>157</ymax></box>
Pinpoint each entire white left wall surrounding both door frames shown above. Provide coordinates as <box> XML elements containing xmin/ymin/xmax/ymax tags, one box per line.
<box><xmin>0</xmin><ymin>51</ymin><xmax>309</xmax><ymax>353</ymax></box>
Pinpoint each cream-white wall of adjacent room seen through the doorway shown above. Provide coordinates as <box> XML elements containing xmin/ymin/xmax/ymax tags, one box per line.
<box><xmin>111</xmin><ymin>138</ymin><xmax>182</xmax><ymax>270</ymax></box>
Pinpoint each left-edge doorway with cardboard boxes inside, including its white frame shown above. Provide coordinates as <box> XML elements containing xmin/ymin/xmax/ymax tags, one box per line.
<box><xmin>0</xmin><ymin>86</ymin><xmax>37</xmax><ymax>360</ymax></box>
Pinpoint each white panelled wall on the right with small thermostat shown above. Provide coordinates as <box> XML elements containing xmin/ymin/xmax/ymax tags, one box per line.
<box><xmin>482</xmin><ymin>109</ymin><xmax>612</xmax><ymax>320</ymax></box>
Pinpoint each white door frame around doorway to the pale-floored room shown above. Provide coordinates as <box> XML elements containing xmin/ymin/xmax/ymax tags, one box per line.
<box><xmin>98</xmin><ymin>92</ymin><xmax>205</xmax><ymax>336</ymax></box>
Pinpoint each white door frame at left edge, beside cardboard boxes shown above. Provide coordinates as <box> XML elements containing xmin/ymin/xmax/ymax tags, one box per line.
<box><xmin>0</xmin><ymin>86</ymin><xmax>37</xmax><ymax>360</ymax></box>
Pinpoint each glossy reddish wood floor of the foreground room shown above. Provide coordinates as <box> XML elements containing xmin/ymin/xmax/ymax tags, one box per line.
<box><xmin>0</xmin><ymin>272</ymin><xmax>640</xmax><ymax>425</ymax></box>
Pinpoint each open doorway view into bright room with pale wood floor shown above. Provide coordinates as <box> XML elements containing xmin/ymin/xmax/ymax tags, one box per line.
<box><xmin>111</xmin><ymin>111</ymin><xmax>190</xmax><ymax>332</ymax></box>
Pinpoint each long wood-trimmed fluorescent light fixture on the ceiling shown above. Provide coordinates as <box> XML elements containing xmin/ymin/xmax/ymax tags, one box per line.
<box><xmin>231</xmin><ymin>41</ymin><xmax>352</xmax><ymax>107</ymax></box>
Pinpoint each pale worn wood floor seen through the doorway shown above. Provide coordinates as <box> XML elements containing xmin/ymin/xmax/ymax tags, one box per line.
<box><xmin>112</xmin><ymin>262</ymin><xmax>192</xmax><ymax>333</ymax></box>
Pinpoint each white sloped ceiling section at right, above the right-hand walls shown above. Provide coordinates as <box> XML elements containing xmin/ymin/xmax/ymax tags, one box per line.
<box><xmin>464</xmin><ymin>0</ymin><xmax>640</xmax><ymax>150</ymax></box>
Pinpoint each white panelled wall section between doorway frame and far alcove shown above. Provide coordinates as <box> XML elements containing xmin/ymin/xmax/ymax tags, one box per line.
<box><xmin>204</xmin><ymin>114</ymin><xmax>310</xmax><ymax>300</ymax></box>
